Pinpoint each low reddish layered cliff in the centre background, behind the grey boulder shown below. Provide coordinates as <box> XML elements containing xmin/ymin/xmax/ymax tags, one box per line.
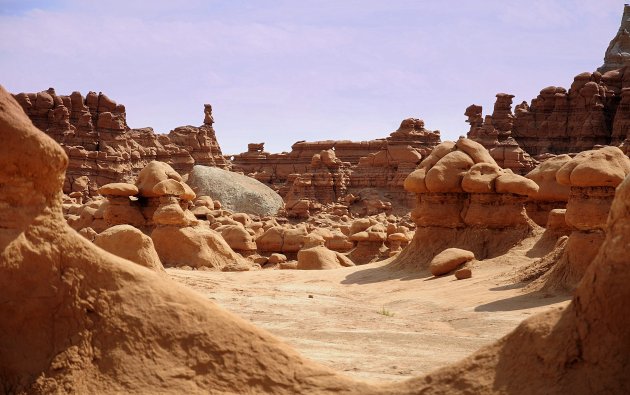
<box><xmin>232</xmin><ymin>118</ymin><xmax>440</xmax><ymax>217</ymax></box>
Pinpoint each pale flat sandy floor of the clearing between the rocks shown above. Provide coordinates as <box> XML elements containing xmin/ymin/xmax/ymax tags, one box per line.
<box><xmin>167</xmin><ymin>235</ymin><xmax>569</xmax><ymax>381</ymax></box>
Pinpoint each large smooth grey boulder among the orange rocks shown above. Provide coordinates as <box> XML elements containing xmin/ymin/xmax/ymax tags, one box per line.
<box><xmin>187</xmin><ymin>165</ymin><xmax>284</xmax><ymax>216</ymax></box>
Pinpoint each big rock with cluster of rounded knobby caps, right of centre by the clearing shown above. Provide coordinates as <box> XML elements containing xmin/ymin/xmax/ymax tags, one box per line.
<box><xmin>393</xmin><ymin>138</ymin><xmax>538</xmax><ymax>269</ymax></box>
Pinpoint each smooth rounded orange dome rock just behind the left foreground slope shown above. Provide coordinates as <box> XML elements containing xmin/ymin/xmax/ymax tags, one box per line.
<box><xmin>94</xmin><ymin>225</ymin><xmax>164</xmax><ymax>272</ymax></box>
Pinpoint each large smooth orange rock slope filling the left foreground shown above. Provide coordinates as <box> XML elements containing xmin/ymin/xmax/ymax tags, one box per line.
<box><xmin>0</xmin><ymin>88</ymin><xmax>380</xmax><ymax>393</ymax></box>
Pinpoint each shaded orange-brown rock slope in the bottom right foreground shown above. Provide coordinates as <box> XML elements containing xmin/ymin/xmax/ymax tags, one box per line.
<box><xmin>397</xmin><ymin>172</ymin><xmax>630</xmax><ymax>395</ymax></box>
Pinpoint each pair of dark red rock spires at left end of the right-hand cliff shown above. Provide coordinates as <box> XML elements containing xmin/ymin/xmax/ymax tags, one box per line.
<box><xmin>464</xmin><ymin>98</ymin><xmax>537</xmax><ymax>175</ymax></box>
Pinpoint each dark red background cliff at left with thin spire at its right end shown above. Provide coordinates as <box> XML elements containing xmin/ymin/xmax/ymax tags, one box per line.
<box><xmin>14</xmin><ymin>88</ymin><xmax>229</xmax><ymax>196</ymax></box>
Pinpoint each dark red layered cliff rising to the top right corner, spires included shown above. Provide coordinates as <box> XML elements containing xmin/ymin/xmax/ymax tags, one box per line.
<box><xmin>465</xmin><ymin>5</ymin><xmax>630</xmax><ymax>159</ymax></box>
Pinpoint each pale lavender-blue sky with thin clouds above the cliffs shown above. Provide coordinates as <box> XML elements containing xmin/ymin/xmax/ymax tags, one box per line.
<box><xmin>0</xmin><ymin>0</ymin><xmax>623</xmax><ymax>154</ymax></box>
